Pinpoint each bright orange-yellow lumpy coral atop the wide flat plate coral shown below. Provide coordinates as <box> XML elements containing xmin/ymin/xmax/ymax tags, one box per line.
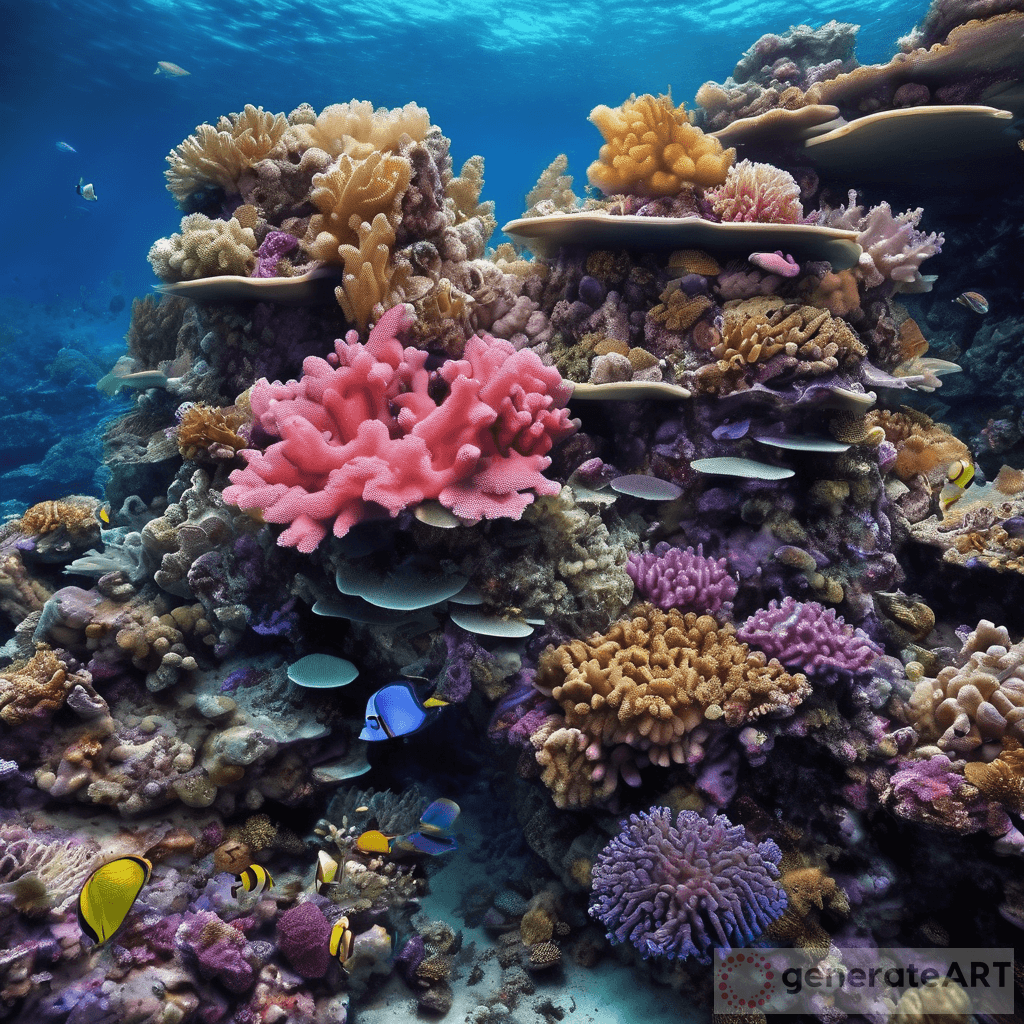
<box><xmin>587</xmin><ymin>93</ymin><xmax>736</xmax><ymax>197</ymax></box>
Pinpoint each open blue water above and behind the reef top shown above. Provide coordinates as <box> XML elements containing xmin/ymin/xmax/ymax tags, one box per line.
<box><xmin>0</xmin><ymin>0</ymin><xmax>927</xmax><ymax>299</ymax></box>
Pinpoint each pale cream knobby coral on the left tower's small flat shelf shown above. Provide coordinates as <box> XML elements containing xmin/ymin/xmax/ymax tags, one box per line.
<box><xmin>148</xmin><ymin>213</ymin><xmax>256</xmax><ymax>281</ymax></box>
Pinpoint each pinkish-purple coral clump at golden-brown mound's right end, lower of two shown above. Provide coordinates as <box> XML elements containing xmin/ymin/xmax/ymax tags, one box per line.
<box><xmin>736</xmin><ymin>597</ymin><xmax>885</xmax><ymax>683</ymax></box>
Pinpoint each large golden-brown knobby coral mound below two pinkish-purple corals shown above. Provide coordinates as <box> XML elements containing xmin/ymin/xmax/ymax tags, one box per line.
<box><xmin>536</xmin><ymin>604</ymin><xmax>811</xmax><ymax>767</ymax></box>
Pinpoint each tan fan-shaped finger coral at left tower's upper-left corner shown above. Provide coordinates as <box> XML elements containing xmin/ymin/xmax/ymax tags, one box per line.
<box><xmin>164</xmin><ymin>103</ymin><xmax>288</xmax><ymax>210</ymax></box>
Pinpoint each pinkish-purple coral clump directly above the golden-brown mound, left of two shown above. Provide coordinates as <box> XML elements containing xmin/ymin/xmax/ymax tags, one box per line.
<box><xmin>626</xmin><ymin>541</ymin><xmax>738</xmax><ymax>617</ymax></box>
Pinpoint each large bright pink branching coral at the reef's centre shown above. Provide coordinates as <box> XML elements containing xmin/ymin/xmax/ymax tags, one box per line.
<box><xmin>224</xmin><ymin>306</ymin><xmax>577</xmax><ymax>552</ymax></box>
